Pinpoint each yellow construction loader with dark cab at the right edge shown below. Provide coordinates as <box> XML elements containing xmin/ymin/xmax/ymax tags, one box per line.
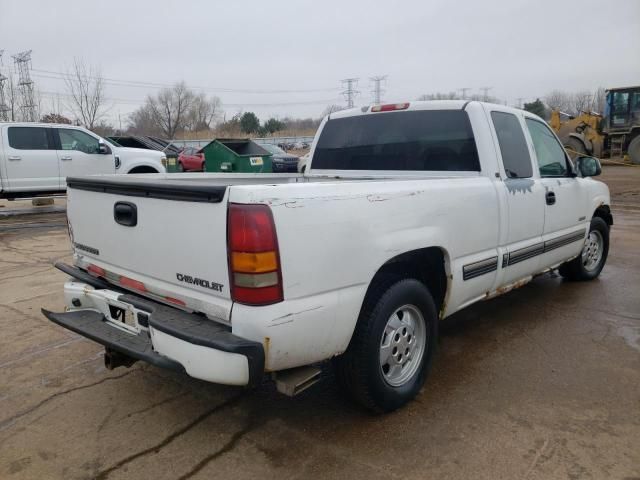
<box><xmin>549</xmin><ymin>86</ymin><xmax>640</xmax><ymax>165</ymax></box>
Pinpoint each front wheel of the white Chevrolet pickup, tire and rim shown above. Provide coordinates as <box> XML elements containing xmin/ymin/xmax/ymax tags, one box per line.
<box><xmin>559</xmin><ymin>217</ymin><xmax>609</xmax><ymax>281</ymax></box>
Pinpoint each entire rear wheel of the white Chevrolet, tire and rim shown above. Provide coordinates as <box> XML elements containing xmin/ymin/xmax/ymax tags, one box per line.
<box><xmin>336</xmin><ymin>279</ymin><xmax>438</xmax><ymax>412</ymax></box>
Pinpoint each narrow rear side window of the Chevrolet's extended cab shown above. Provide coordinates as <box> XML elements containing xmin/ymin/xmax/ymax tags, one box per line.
<box><xmin>491</xmin><ymin>112</ymin><xmax>533</xmax><ymax>178</ymax></box>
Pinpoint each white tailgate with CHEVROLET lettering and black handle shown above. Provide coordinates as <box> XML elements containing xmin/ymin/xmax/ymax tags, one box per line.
<box><xmin>67</xmin><ymin>176</ymin><xmax>232</xmax><ymax>322</ymax></box>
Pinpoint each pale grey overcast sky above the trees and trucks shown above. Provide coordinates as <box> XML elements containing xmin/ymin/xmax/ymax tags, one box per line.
<box><xmin>0</xmin><ymin>0</ymin><xmax>640</xmax><ymax>123</ymax></box>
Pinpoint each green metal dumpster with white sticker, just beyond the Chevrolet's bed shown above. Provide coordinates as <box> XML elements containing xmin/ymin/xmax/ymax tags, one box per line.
<box><xmin>200</xmin><ymin>138</ymin><xmax>273</xmax><ymax>173</ymax></box>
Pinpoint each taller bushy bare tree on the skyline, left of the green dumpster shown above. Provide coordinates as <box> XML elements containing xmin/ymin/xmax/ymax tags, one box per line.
<box><xmin>146</xmin><ymin>82</ymin><xmax>194</xmax><ymax>139</ymax></box>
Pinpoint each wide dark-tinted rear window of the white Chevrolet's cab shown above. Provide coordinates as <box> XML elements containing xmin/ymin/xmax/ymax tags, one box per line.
<box><xmin>313</xmin><ymin>110</ymin><xmax>480</xmax><ymax>171</ymax></box>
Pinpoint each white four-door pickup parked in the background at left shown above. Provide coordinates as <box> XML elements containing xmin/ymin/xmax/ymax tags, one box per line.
<box><xmin>0</xmin><ymin>122</ymin><xmax>167</xmax><ymax>199</ymax></box>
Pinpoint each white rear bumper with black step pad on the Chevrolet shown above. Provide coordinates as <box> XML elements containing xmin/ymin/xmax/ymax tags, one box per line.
<box><xmin>42</xmin><ymin>267</ymin><xmax>264</xmax><ymax>385</ymax></box>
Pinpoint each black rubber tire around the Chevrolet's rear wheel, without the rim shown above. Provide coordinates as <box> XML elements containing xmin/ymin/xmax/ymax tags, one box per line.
<box><xmin>335</xmin><ymin>277</ymin><xmax>438</xmax><ymax>413</ymax></box>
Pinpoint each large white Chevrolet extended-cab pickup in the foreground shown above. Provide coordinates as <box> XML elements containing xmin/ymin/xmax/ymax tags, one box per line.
<box><xmin>43</xmin><ymin>101</ymin><xmax>613</xmax><ymax>411</ymax></box>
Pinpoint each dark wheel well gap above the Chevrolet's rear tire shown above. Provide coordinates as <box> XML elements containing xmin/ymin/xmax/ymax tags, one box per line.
<box><xmin>367</xmin><ymin>247</ymin><xmax>447</xmax><ymax>312</ymax></box>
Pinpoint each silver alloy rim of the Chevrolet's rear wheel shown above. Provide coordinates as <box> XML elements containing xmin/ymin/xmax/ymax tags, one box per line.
<box><xmin>380</xmin><ymin>305</ymin><xmax>427</xmax><ymax>387</ymax></box>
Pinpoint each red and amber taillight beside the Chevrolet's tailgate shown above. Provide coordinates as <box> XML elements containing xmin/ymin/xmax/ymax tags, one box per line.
<box><xmin>227</xmin><ymin>203</ymin><xmax>283</xmax><ymax>305</ymax></box>
